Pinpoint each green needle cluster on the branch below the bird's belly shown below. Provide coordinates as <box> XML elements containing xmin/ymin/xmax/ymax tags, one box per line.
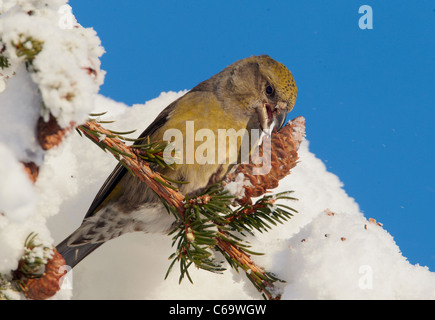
<box><xmin>165</xmin><ymin>183</ymin><xmax>297</xmax><ymax>297</ymax></box>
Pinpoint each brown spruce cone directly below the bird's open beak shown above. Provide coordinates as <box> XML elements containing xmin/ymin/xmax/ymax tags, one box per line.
<box><xmin>225</xmin><ymin>116</ymin><xmax>305</xmax><ymax>204</ymax></box>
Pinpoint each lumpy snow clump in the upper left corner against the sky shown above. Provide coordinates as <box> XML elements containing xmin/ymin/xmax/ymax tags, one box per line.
<box><xmin>0</xmin><ymin>0</ymin><xmax>105</xmax><ymax>128</ymax></box>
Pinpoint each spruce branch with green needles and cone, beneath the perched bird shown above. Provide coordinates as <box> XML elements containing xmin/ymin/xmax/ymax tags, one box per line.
<box><xmin>77</xmin><ymin>114</ymin><xmax>302</xmax><ymax>299</ymax></box>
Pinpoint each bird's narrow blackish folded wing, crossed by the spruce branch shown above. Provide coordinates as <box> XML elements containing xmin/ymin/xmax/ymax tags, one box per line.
<box><xmin>85</xmin><ymin>101</ymin><xmax>176</xmax><ymax>219</ymax></box>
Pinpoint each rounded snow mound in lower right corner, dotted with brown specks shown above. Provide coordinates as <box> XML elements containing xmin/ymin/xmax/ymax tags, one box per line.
<box><xmin>276</xmin><ymin>213</ymin><xmax>435</xmax><ymax>299</ymax></box>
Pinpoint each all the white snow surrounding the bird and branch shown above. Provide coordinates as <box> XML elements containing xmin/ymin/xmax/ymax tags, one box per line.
<box><xmin>0</xmin><ymin>0</ymin><xmax>435</xmax><ymax>299</ymax></box>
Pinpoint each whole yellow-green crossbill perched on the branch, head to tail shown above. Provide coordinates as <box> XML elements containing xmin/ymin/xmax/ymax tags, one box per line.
<box><xmin>57</xmin><ymin>55</ymin><xmax>297</xmax><ymax>267</ymax></box>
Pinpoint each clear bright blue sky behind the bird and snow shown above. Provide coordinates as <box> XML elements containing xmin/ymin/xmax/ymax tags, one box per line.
<box><xmin>70</xmin><ymin>0</ymin><xmax>435</xmax><ymax>271</ymax></box>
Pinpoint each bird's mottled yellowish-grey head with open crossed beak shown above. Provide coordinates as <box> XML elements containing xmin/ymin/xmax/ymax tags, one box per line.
<box><xmin>210</xmin><ymin>55</ymin><xmax>297</xmax><ymax>131</ymax></box>
